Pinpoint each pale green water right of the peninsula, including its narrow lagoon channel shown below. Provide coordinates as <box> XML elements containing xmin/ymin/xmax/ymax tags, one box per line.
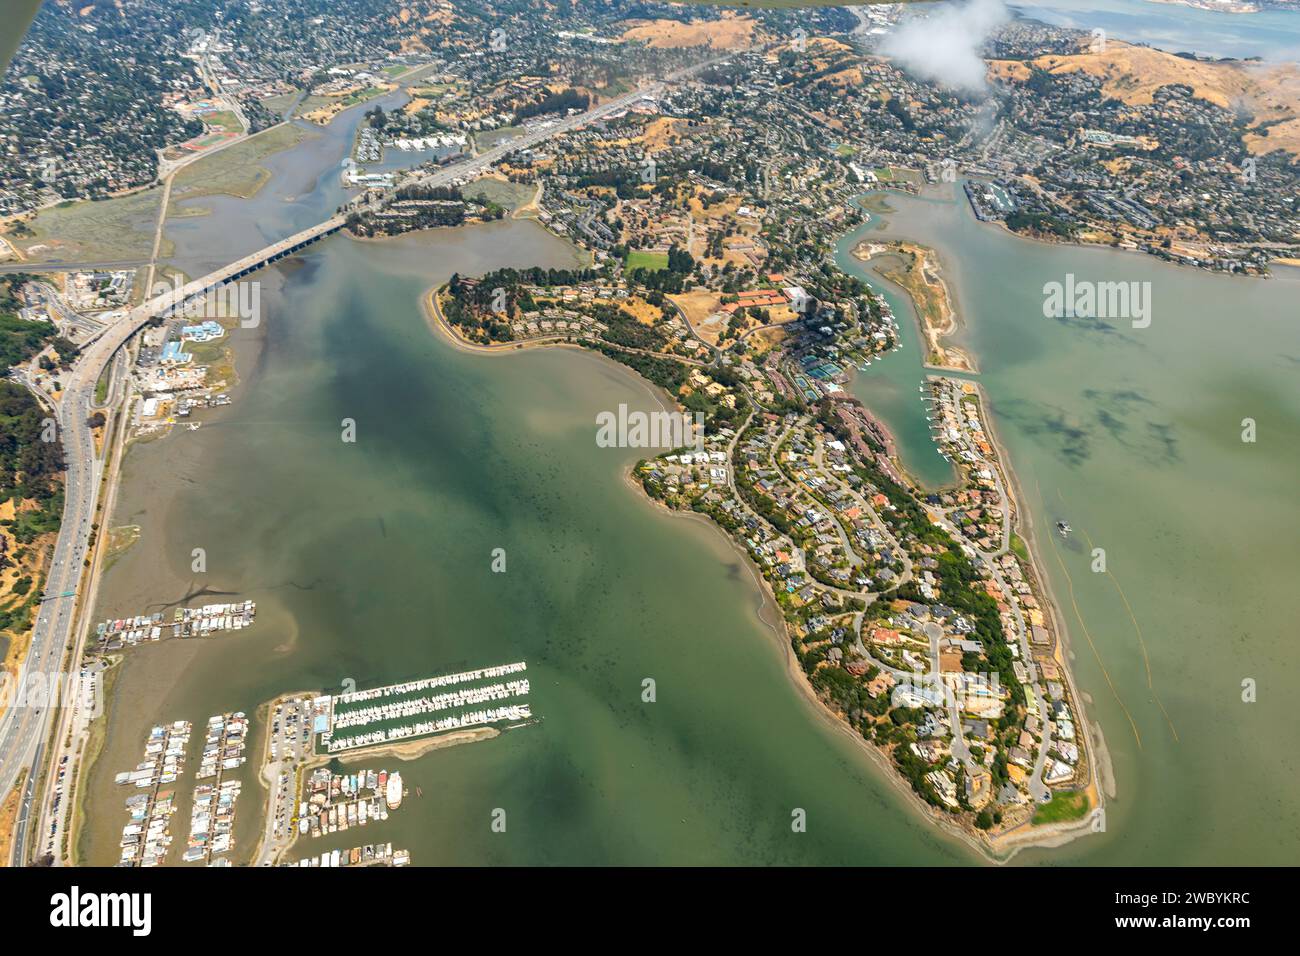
<box><xmin>837</xmin><ymin>193</ymin><xmax>1300</xmax><ymax>864</ymax></box>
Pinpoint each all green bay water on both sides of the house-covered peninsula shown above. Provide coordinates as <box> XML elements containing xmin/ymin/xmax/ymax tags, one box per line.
<box><xmin>81</xmin><ymin>198</ymin><xmax>1300</xmax><ymax>864</ymax></box>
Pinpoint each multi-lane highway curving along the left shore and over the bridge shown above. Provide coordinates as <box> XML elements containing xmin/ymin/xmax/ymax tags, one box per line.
<box><xmin>0</xmin><ymin>52</ymin><xmax>736</xmax><ymax>864</ymax></box>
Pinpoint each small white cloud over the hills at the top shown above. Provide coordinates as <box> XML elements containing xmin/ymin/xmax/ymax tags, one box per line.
<box><xmin>880</xmin><ymin>0</ymin><xmax>1010</xmax><ymax>91</ymax></box>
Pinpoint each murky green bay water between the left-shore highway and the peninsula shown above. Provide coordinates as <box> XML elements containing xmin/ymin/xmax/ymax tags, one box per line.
<box><xmin>81</xmin><ymin>222</ymin><xmax>975</xmax><ymax>865</ymax></box>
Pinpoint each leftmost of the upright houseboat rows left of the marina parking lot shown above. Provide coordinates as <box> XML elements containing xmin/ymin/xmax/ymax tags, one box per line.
<box><xmin>114</xmin><ymin>721</ymin><xmax>191</xmax><ymax>866</ymax></box>
